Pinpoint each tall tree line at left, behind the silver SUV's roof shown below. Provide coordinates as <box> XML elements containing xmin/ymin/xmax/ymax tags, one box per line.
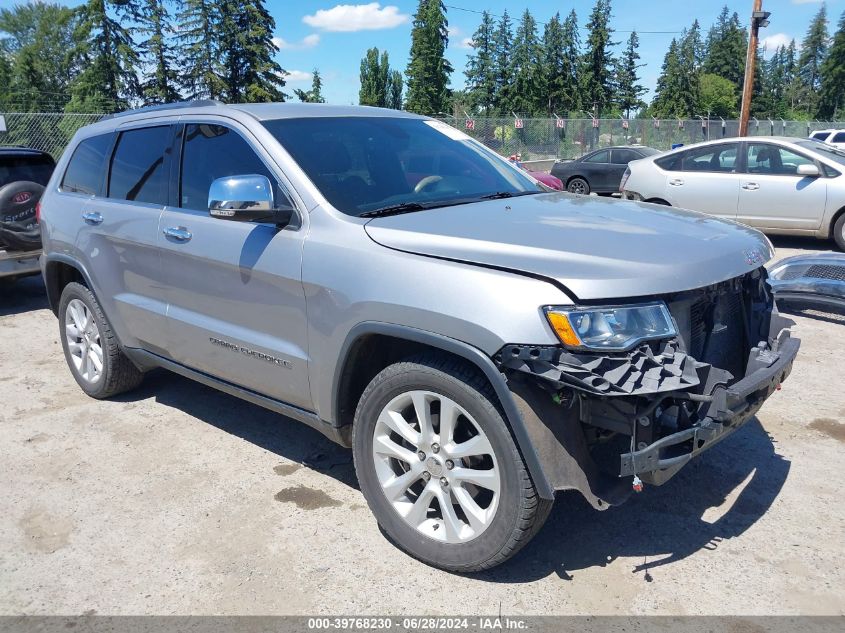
<box><xmin>0</xmin><ymin>0</ymin><xmax>323</xmax><ymax>112</ymax></box>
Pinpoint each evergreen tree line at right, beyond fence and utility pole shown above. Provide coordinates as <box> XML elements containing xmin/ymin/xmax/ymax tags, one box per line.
<box><xmin>462</xmin><ymin>0</ymin><xmax>845</xmax><ymax>120</ymax></box>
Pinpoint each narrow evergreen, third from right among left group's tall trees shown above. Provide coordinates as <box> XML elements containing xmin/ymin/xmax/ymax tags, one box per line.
<box><xmin>138</xmin><ymin>0</ymin><xmax>181</xmax><ymax>105</ymax></box>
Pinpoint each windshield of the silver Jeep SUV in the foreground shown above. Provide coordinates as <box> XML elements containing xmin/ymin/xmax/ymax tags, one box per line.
<box><xmin>264</xmin><ymin>117</ymin><xmax>545</xmax><ymax>215</ymax></box>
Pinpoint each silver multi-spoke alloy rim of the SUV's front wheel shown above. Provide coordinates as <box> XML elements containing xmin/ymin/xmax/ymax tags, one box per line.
<box><xmin>373</xmin><ymin>390</ymin><xmax>502</xmax><ymax>543</ymax></box>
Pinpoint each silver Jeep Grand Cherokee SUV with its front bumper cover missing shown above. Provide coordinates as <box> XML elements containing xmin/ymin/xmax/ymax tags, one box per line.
<box><xmin>41</xmin><ymin>102</ymin><xmax>799</xmax><ymax>572</ymax></box>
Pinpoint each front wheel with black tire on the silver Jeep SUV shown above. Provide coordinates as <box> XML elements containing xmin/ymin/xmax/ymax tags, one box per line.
<box><xmin>353</xmin><ymin>354</ymin><xmax>552</xmax><ymax>572</ymax></box>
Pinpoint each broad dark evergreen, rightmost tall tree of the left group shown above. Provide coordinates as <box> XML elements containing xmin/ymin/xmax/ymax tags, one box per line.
<box><xmin>220</xmin><ymin>0</ymin><xmax>286</xmax><ymax>103</ymax></box>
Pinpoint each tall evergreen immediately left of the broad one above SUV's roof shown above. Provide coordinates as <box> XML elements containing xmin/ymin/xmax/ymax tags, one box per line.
<box><xmin>176</xmin><ymin>0</ymin><xmax>225</xmax><ymax>99</ymax></box>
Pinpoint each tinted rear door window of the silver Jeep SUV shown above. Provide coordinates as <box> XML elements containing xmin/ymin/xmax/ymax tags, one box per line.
<box><xmin>108</xmin><ymin>126</ymin><xmax>170</xmax><ymax>205</ymax></box>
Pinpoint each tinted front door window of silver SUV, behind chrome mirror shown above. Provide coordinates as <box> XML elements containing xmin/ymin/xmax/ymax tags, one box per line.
<box><xmin>179</xmin><ymin>123</ymin><xmax>280</xmax><ymax>211</ymax></box>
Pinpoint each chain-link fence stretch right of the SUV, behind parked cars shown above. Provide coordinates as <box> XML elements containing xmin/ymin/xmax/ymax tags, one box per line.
<box><xmin>442</xmin><ymin>117</ymin><xmax>845</xmax><ymax>161</ymax></box>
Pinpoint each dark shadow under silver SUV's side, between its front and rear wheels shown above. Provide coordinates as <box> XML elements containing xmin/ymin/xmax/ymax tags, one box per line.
<box><xmin>113</xmin><ymin>369</ymin><xmax>358</xmax><ymax>490</ymax></box>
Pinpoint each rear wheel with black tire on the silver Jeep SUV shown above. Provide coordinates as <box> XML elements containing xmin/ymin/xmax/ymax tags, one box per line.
<box><xmin>59</xmin><ymin>282</ymin><xmax>143</xmax><ymax>399</ymax></box>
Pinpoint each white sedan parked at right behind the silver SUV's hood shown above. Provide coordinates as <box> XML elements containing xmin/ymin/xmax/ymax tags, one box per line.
<box><xmin>619</xmin><ymin>136</ymin><xmax>845</xmax><ymax>250</ymax></box>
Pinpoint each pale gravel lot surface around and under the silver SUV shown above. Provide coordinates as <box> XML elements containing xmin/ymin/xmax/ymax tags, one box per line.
<box><xmin>0</xmin><ymin>239</ymin><xmax>845</xmax><ymax>615</ymax></box>
